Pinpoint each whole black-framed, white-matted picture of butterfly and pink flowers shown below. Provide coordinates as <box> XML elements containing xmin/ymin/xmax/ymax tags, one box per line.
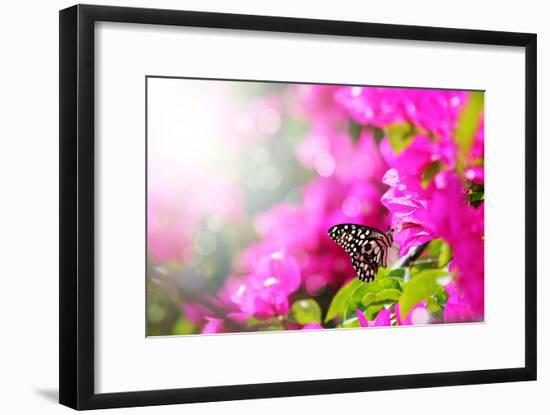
<box><xmin>59</xmin><ymin>5</ymin><xmax>537</xmax><ymax>409</ymax></box>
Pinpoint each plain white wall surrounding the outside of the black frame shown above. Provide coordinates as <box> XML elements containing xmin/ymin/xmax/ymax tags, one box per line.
<box><xmin>0</xmin><ymin>0</ymin><xmax>550</xmax><ymax>415</ymax></box>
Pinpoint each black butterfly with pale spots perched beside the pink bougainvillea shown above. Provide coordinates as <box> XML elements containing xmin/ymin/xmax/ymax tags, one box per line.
<box><xmin>328</xmin><ymin>223</ymin><xmax>394</xmax><ymax>282</ymax></box>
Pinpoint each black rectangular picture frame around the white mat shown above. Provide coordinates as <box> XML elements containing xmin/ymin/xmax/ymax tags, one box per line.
<box><xmin>59</xmin><ymin>5</ymin><xmax>537</xmax><ymax>409</ymax></box>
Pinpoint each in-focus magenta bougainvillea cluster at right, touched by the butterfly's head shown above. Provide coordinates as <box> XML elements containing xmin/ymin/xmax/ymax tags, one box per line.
<box><xmin>381</xmin><ymin>134</ymin><xmax>484</xmax><ymax>322</ymax></box>
